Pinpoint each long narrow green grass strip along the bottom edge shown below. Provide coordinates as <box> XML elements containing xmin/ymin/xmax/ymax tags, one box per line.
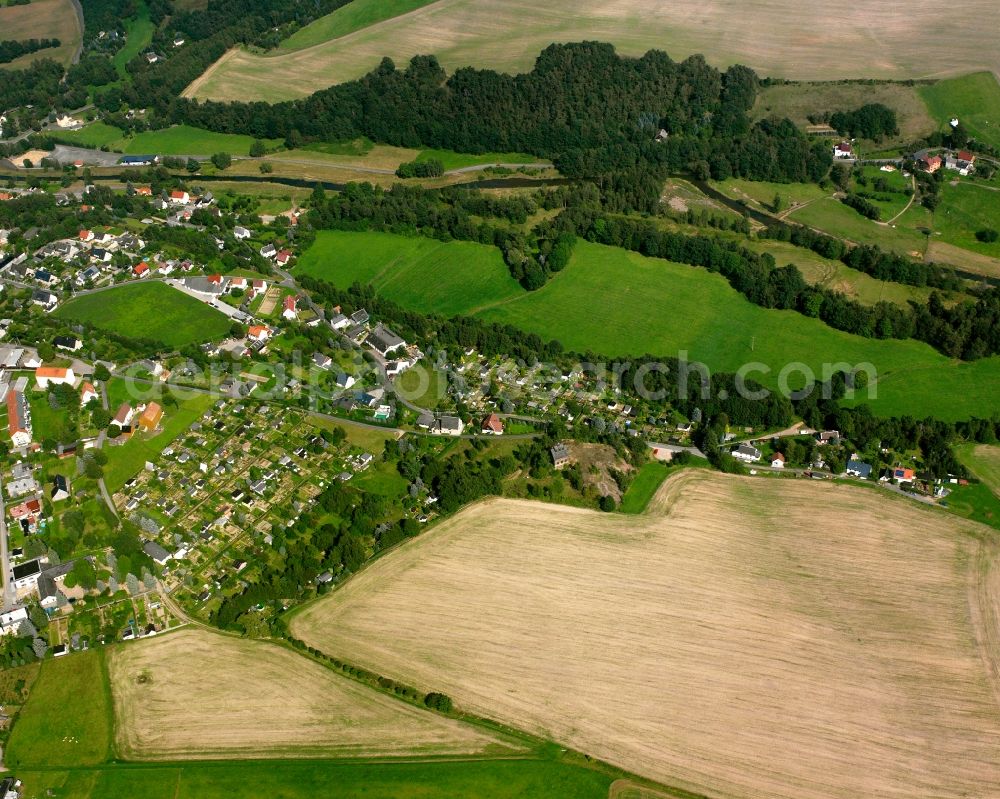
<box><xmin>18</xmin><ymin>760</ymin><xmax>611</xmax><ymax>799</ymax></box>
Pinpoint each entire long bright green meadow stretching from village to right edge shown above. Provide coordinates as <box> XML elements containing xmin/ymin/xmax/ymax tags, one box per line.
<box><xmin>299</xmin><ymin>230</ymin><xmax>1000</xmax><ymax>419</ymax></box>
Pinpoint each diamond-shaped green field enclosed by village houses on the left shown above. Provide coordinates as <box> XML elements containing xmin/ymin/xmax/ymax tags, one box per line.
<box><xmin>55</xmin><ymin>282</ymin><xmax>231</xmax><ymax>349</ymax></box>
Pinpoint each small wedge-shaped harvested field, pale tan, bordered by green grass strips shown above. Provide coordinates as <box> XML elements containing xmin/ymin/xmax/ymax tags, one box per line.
<box><xmin>109</xmin><ymin>630</ymin><xmax>510</xmax><ymax>760</ymax></box>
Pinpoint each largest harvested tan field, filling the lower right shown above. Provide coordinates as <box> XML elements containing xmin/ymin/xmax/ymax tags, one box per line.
<box><xmin>293</xmin><ymin>471</ymin><xmax>1000</xmax><ymax>799</ymax></box>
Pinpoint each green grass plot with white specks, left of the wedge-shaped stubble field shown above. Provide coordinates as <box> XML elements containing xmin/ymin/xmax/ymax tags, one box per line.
<box><xmin>4</xmin><ymin>650</ymin><xmax>114</xmax><ymax>768</ymax></box>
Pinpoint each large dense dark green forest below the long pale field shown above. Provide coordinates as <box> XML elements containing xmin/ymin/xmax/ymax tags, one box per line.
<box><xmin>171</xmin><ymin>42</ymin><xmax>831</xmax><ymax>210</ymax></box>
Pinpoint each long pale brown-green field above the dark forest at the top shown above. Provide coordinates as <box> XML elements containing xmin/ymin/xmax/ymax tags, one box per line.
<box><xmin>186</xmin><ymin>0</ymin><xmax>1000</xmax><ymax>101</ymax></box>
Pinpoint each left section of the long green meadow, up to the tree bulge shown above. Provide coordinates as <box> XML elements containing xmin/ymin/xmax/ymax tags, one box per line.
<box><xmin>295</xmin><ymin>231</ymin><xmax>525</xmax><ymax>315</ymax></box>
